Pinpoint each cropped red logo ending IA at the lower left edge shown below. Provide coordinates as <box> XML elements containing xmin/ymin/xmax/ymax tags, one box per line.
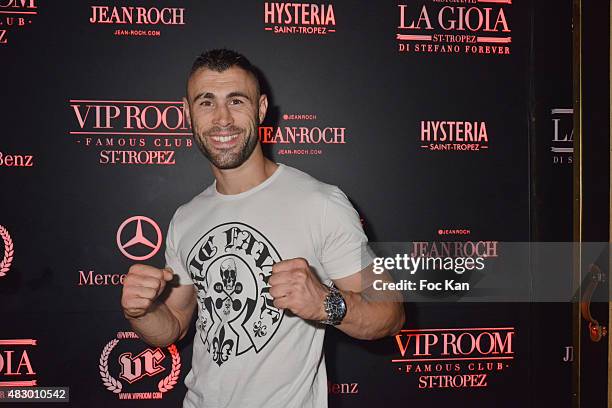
<box><xmin>0</xmin><ymin>339</ymin><xmax>37</xmax><ymax>387</ymax></box>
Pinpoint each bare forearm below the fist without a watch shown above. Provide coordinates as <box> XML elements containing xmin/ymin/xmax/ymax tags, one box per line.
<box><xmin>126</xmin><ymin>302</ymin><xmax>181</xmax><ymax>347</ymax></box>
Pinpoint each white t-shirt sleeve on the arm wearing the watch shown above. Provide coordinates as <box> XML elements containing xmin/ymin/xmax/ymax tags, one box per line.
<box><xmin>321</xmin><ymin>186</ymin><xmax>373</xmax><ymax>279</ymax></box>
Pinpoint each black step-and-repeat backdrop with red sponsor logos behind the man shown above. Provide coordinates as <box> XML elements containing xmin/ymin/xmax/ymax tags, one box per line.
<box><xmin>0</xmin><ymin>0</ymin><xmax>572</xmax><ymax>407</ymax></box>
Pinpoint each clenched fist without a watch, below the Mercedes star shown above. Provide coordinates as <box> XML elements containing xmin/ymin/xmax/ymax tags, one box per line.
<box><xmin>121</xmin><ymin>264</ymin><xmax>174</xmax><ymax>319</ymax></box>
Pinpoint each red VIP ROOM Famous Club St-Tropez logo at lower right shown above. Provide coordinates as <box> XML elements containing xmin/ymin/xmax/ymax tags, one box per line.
<box><xmin>391</xmin><ymin>327</ymin><xmax>516</xmax><ymax>390</ymax></box>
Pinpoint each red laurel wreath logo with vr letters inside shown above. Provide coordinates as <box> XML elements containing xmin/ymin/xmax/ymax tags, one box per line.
<box><xmin>98</xmin><ymin>332</ymin><xmax>181</xmax><ymax>400</ymax></box>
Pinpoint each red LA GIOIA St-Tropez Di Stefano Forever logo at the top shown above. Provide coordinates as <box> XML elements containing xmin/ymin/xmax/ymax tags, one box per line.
<box><xmin>395</xmin><ymin>0</ymin><xmax>512</xmax><ymax>55</ymax></box>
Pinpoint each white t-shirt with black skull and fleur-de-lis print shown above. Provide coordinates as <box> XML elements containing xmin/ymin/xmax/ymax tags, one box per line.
<box><xmin>166</xmin><ymin>164</ymin><xmax>371</xmax><ymax>408</ymax></box>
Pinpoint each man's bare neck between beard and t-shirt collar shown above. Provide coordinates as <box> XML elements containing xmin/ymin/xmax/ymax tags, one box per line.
<box><xmin>212</xmin><ymin>152</ymin><xmax>278</xmax><ymax>195</ymax></box>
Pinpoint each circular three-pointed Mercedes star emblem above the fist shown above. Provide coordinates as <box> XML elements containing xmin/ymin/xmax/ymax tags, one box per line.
<box><xmin>117</xmin><ymin>215</ymin><xmax>162</xmax><ymax>261</ymax></box>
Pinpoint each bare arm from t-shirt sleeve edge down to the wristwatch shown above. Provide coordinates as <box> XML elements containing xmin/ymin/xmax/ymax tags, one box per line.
<box><xmin>334</xmin><ymin>265</ymin><xmax>405</xmax><ymax>340</ymax></box>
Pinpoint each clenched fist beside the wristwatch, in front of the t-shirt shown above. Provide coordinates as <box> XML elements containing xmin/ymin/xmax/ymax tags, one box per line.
<box><xmin>268</xmin><ymin>258</ymin><xmax>329</xmax><ymax>321</ymax></box>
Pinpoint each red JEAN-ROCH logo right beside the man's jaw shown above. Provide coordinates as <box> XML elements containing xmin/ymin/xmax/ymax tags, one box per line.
<box><xmin>259</xmin><ymin>113</ymin><xmax>348</xmax><ymax>155</ymax></box>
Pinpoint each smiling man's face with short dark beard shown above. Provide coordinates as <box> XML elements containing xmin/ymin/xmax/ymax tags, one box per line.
<box><xmin>184</xmin><ymin>67</ymin><xmax>268</xmax><ymax>169</ymax></box>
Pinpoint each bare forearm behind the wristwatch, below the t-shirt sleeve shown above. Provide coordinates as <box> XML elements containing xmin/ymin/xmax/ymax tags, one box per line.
<box><xmin>336</xmin><ymin>290</ymin><xmax>405</xmax><ymax>340</ymax></box>
